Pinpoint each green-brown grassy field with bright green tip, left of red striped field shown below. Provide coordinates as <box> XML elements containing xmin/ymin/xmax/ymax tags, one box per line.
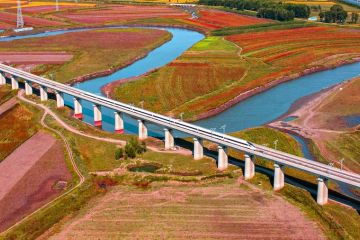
<box><xmin>112</xmin><ymin>37</ymin><xmax>248</xmax><ymax>118</ymax></box>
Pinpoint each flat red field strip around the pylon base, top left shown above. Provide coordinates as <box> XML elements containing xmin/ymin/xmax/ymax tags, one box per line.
<box><xmin>0</xmin><ymin>12</ymin><xmax>64</xmax><ymax>28</ymax></box>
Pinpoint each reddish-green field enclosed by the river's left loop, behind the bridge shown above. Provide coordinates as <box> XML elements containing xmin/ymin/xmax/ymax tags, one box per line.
<box><xmin>0</xmin><ymin>29</ymin><xmax>171</xmax><ymax>83</ymax></box>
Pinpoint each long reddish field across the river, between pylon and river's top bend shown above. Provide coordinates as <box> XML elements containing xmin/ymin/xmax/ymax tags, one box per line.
<box><xmin>57</xmin><ymin>5</ymin><xmax>188</xmax><ymax>24</ymax></box>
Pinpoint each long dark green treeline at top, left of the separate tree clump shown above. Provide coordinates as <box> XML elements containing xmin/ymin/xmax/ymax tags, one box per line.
<box><xmin>199</xmin><ymin>0</ymin><xmax>310</xmax><ymax>21</ymax></box>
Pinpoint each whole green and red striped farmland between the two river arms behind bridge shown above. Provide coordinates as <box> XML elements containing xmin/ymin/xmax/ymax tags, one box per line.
<box><xmin>113</xmin><ymin>24</ymin><xmax>360</xmax><ymax>120</ymax></box>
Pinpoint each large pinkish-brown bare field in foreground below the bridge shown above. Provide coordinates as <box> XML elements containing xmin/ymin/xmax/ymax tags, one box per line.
<box><xmin>53</xmin><ymin>183</ymin><xmax>324</xmax><ymax>239</ymax></box>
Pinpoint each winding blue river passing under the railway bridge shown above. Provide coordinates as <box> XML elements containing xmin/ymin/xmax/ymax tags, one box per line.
<box><xmin>0</xmin><ymin>26</ymin><xmax>360</xmax><ymax>199</ymax></box>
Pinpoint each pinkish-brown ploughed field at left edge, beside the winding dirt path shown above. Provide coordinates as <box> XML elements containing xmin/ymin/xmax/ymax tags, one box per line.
<box><xmin>0</xmin><ymin>132</ymin><xmax>71</xmax><ymax>231</ymax></box>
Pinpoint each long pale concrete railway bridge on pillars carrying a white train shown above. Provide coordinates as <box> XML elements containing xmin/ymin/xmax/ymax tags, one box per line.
<box><xmin>0</xmin><ymin>64</ymin><xmax>360</xmax><ymax>205</ymax></box>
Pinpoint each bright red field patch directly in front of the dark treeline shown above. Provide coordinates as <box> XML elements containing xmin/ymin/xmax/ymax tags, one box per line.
<box><xmin>187</xmin><ymin>10</ymin><xmax>269</xmax><ymax>29</ymax></box>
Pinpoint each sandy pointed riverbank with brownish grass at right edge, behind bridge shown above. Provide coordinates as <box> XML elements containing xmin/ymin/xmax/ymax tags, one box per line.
<box><xmin>268</xmin><ymin>78</ymin><xmax>360</xmax><ymax>173</ymax></box>
